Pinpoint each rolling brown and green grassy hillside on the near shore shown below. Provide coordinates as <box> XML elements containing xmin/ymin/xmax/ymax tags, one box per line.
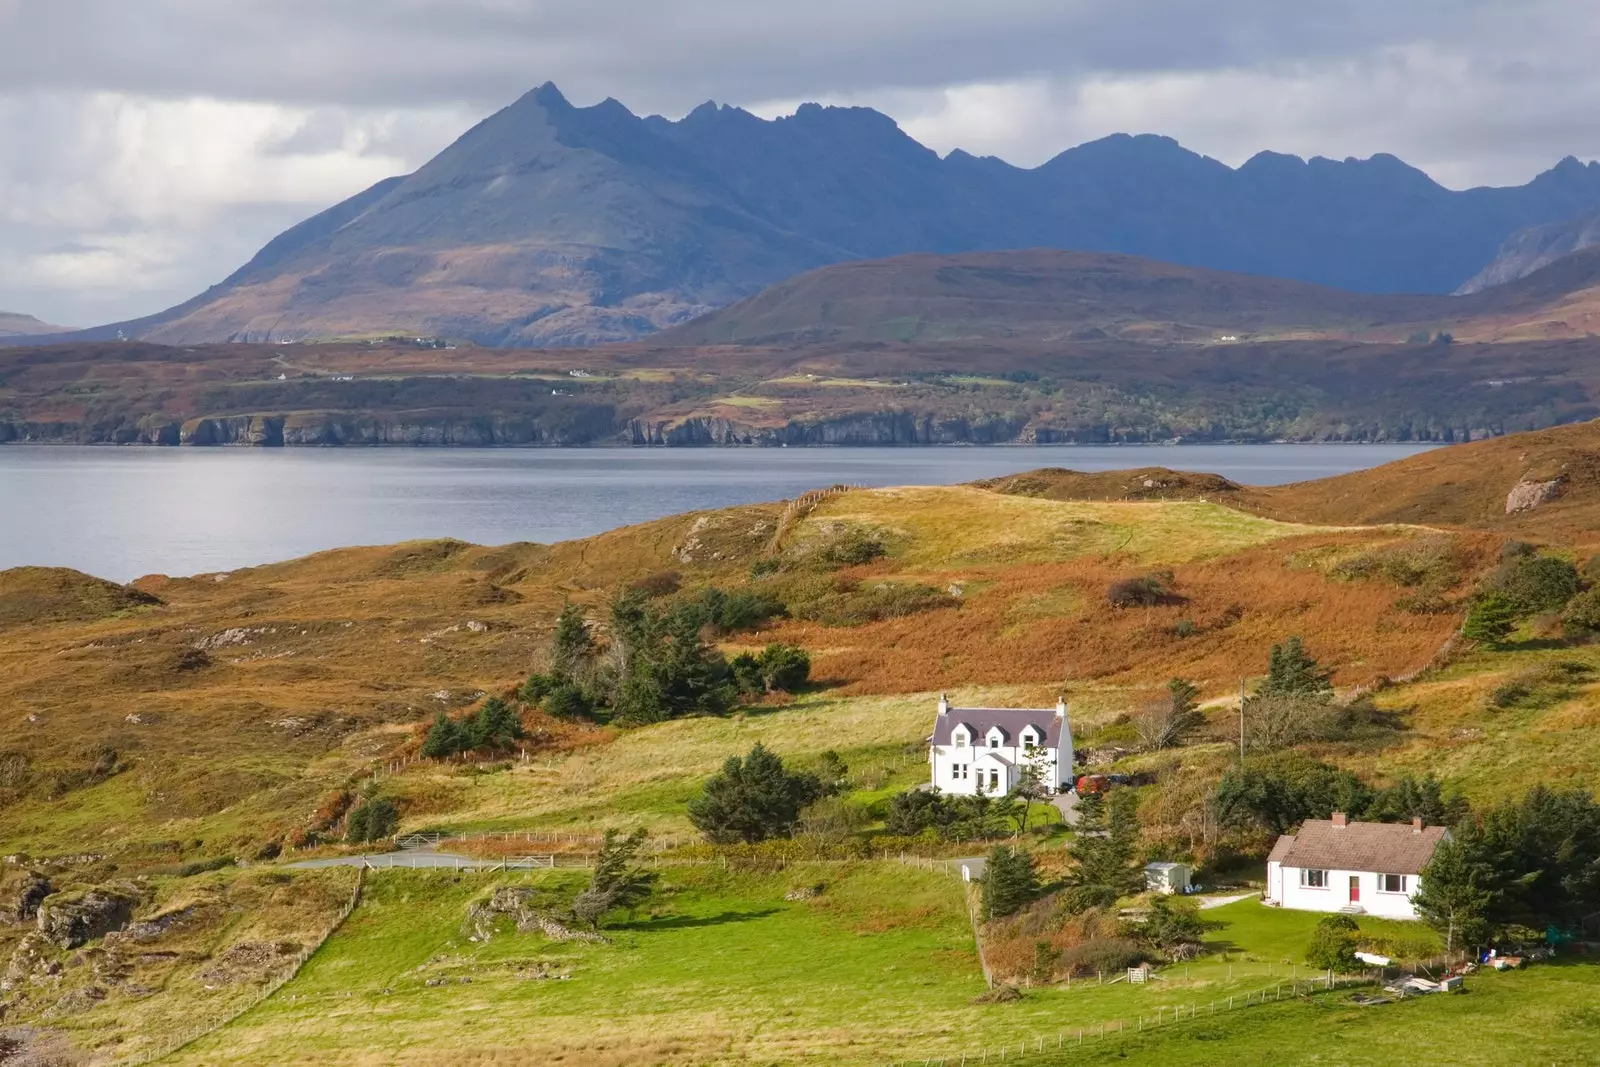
<box><xmin>0</xmin><ymin>426</ymin><xmax>1600</xmax><ymax>1067</ymax></box>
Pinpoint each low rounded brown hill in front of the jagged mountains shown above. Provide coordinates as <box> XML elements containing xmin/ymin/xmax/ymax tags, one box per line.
<box><xmin>654</xmin><ymin>248</ymin><xmax>1600</xmax><ymax>346</ymax></box>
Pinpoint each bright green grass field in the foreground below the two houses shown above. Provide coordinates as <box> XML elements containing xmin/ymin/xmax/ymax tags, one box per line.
<box><xmin>159</xmin><ymin>862</ymin><xmax>1574</xmax><ymax>1065</ymax></box>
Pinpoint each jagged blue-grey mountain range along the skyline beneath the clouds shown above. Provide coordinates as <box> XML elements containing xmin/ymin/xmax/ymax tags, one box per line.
<box><xmin>37</xmin><ymin>85</ymin><xmax>1600</xmax><ymax>346</ymax></box>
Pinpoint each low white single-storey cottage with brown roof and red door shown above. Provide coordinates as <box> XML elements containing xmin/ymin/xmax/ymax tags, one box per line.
<box><xmin>1266</xmin><ymin>811</ymin><xmax>1450</xmax><ymax>918</ymax></box>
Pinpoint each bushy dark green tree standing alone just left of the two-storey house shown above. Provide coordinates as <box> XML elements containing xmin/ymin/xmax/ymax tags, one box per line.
<box><xmin>688</xmin><ymin>744</ymin><xmax>822</xmax><ymax>845</ymax></box>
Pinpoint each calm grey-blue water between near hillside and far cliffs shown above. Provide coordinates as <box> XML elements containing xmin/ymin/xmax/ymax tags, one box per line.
<box><xmin>0</xmin><ymin>445</ymin><xmax>1440</xmax><ymax>581</ymax></box>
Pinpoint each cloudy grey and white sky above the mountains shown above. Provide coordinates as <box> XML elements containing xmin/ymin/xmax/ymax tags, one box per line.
<box><xmin>0</xmin><ymin>0</ymin><xmax>1600</xmax><ymax>326</ymax></box>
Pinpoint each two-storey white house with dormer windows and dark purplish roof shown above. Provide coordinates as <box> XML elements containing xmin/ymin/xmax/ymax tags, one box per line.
<box><xmin>928</xmin><ymin>696</ymin><xmax>1072</xmax><ymax>797</ymax></box>
